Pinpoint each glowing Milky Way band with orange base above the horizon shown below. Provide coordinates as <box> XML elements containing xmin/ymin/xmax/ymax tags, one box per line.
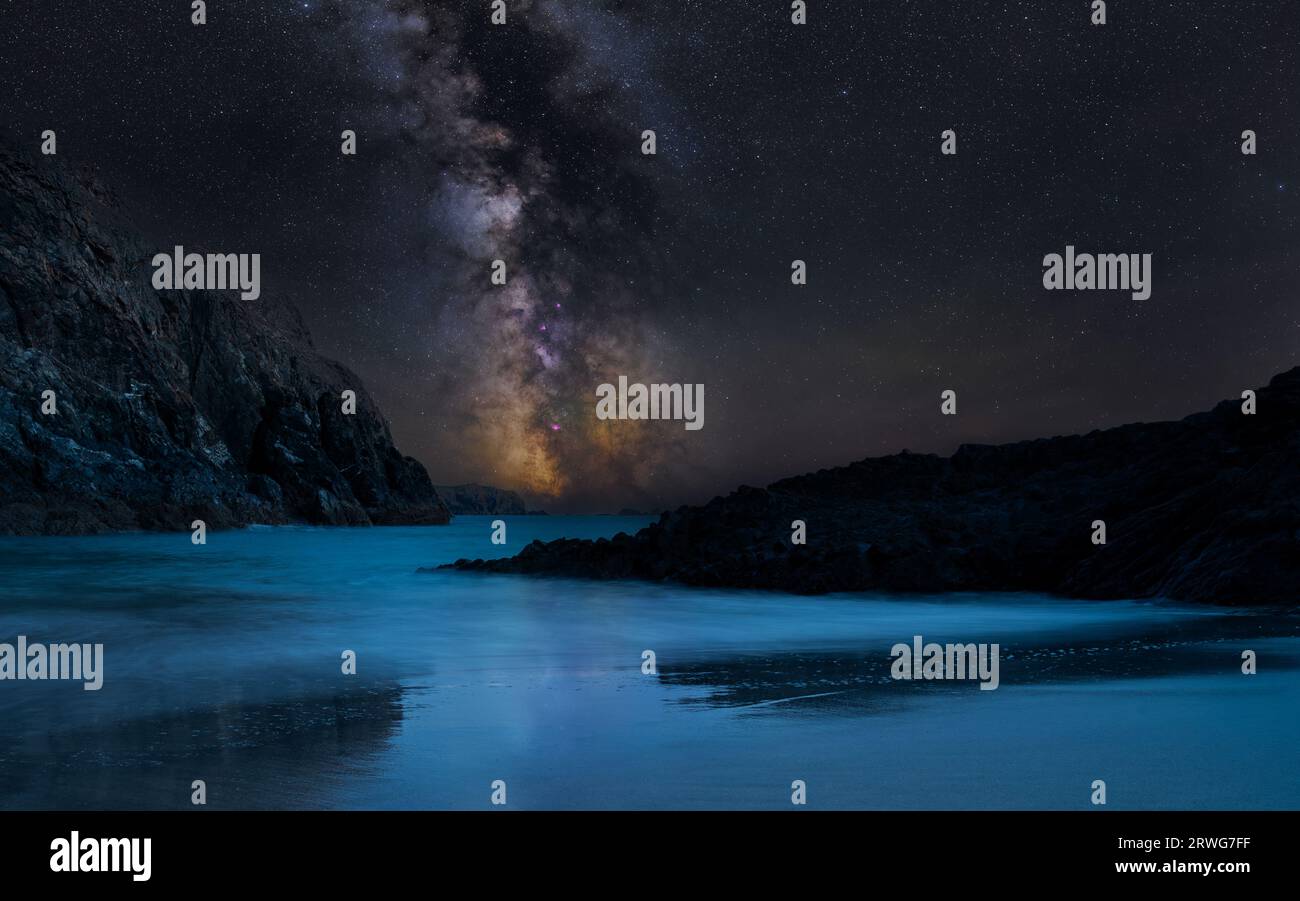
<box><xmin>341</xmin><ymin>1</ymin><xmax>681</xmax><ymax>502</ymax></box>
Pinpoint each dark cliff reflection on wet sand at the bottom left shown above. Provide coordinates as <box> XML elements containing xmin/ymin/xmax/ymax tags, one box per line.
<box><xmin>0</xmin><ymin>683</ymin><xmax>403</xmax><ymax>810</ymax></box>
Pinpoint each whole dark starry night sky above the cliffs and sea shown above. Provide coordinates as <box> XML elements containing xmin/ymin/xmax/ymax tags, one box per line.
<box><xmin>0</xmin><ymin>0</ymin><xmax>1300</xmax><ymax>512</ymax></box>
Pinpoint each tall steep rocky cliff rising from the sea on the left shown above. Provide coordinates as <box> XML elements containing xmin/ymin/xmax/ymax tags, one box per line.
<box><xmin>0</xmin><ymin>148</ymin><xmax>449</xmax><ymax>534</ymax></box>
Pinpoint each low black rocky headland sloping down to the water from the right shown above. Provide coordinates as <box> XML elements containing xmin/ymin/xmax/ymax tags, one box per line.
<box><xmin>452</xmin><ymin>368</ymin><xmax>1300</xmax><ymax>605</ymax></box>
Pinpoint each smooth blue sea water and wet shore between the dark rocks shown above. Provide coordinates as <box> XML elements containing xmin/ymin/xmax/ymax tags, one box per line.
<box><xmin>0</xmin><ymin>516</ymin><xmax>1300</xmax><ymax>809</ymax></box>
